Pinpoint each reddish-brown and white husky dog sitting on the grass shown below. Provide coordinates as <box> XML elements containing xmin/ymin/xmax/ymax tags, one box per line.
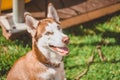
<box><xmin>7</xmin><ymin>4</ymin><xmax>69</xmax><ymax>80</ymax></box>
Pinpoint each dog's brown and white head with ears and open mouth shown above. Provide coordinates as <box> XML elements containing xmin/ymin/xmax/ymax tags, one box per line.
<box><xmin>25</xmin><ymin>4</ymin><xmax>69</xmax><ymax>56</ymax></box>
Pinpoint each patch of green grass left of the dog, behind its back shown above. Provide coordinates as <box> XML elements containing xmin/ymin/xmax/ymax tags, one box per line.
<box><xmin>0</xmin><ymin>29</ymin><xmax>30</xmax><ymax>80</ymax></box>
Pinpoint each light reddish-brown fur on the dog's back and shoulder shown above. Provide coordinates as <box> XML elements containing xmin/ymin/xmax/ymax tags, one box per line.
<box><xmin>7</xmin><ymin>51</ymin><xmax>47</xmax><ymax>80</ymax></box>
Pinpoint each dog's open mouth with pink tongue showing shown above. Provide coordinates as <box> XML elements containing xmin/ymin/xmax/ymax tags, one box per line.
<box><xmin>49</xmin><ymin>45</ymin><xmax>69</xmax><ymax>56</ymax></box>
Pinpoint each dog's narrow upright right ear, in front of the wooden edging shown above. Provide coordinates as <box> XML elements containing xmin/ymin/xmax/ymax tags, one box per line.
<box><xmin>47</xmin><ymin>3</ymin><xmax>59</xmax><ymax>22</ymax></box>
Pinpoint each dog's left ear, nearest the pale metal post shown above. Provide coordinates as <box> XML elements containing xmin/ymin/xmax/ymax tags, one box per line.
<box><xmin>25</xmin><ymin>15</ymin><xmax>39</xmax><ymax>37</ymax></box>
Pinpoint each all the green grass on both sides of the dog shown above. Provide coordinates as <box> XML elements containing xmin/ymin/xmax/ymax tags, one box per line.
<box><xmin>0</xmin><ymin>15</ymin><xmax>120</xmax><ymax>80</ymax></box>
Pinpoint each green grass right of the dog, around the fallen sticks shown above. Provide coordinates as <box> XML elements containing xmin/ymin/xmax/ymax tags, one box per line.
<box><xmin>65</xmin><ymin>15</ymin><xmax>120</xmax><ymax>80</ymax></box>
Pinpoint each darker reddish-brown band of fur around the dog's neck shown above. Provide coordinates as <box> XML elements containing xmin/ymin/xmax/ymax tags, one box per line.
<box><xmin>32</xmin><ymin>39</ymin><xmax>63</xmax><ymax>68</ymax></box>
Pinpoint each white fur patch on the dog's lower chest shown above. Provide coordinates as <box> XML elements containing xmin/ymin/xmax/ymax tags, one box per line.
<box><xmin>38</xmin><ymin>63</ymin><xmax>66</xmax><ymax>80</ymax></box>
